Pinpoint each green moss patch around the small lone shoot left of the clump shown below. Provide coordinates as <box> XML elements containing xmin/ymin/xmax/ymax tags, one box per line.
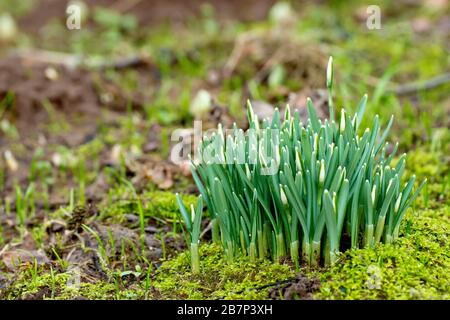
<box><xmin>153</xmin><ymin>244</ymin><xmax>294</xmax><ymax>299</ymax></box>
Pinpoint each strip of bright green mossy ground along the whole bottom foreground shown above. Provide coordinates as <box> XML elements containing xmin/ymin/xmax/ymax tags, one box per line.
<box><xmin>4</xmin><ymin>206</ymin><xmax>450</xmax><ymax>299</ymax></box>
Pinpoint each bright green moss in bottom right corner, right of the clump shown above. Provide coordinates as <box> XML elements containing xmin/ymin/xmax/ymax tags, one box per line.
<box><xmin>315</xmin><ymin>207</ymin><xmax>450</xmax><ymax>299</ymax></box>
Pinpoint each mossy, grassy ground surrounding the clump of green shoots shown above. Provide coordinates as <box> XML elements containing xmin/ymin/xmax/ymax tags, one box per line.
<box><xmin>0</xmin><ymin>1</ymin><xmax>450</xmax><ymax>299</ymax></box>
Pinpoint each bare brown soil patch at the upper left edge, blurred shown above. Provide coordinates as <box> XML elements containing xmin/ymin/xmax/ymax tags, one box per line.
<box><xmin>0</xmin><ymin>52</ymin><xmax>158</xmax><ymax>130</ymax></box>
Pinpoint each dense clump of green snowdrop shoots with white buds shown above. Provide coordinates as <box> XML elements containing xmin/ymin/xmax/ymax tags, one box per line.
<box><xmin>179</xmin><ymin>58</ymin><xmax>425</xmax><ymax>268</ymax></box>
